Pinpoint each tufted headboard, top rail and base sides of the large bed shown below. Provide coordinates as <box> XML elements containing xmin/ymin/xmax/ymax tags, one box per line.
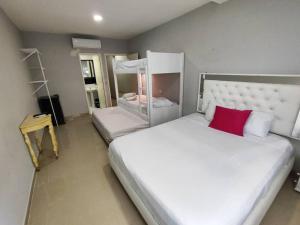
<box><xmin>109</xmin><ymin>73</ymin><xmax>300</xmax><ymax>225</ymax></box>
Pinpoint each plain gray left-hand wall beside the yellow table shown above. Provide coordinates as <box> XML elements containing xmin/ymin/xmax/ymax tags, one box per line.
<box><xmin>0</xmin><ymin>8</ymin><xmax>37</xmax><ymax>225</ymax></box>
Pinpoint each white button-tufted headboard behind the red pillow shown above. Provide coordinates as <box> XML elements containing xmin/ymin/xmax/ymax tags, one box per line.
<box><xmin>198</xmin><ymin>80</ymin><xmax>300</xmax><ymax>137</ymax></box>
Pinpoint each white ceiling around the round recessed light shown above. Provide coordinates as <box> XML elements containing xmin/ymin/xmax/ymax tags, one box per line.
<box><xmin>0</xmin><ymin>0</ymin><xmax>224</xmax><ymax>39</ymax></box>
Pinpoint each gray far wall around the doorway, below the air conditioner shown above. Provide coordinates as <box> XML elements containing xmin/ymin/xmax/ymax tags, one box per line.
<box><xmin>22</xmin><ymin>32</ymin><xmax>127</xmax><ymax>116</ymax></box>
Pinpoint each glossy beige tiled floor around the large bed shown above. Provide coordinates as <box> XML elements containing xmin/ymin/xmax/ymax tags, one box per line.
<box><xmin>28</xmin><ymin>116</ymin><xmax>300</xmax><ymax>225</ymax></box>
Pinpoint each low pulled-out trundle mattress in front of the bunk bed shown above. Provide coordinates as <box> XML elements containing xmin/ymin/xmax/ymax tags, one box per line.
<box><xmin>92</xmin><ymin>107</ymin><xmax>149</xmax><ymax>142</ymax></box>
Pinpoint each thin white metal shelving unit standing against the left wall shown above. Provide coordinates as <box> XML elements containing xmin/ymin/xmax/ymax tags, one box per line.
<box><xmin>20</xmin><ymin>48</ymin><xmax>58</xmax><ymax>126</ymax></box>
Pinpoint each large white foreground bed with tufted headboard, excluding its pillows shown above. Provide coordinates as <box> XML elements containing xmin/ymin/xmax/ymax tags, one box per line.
<box><xmin>109</xmin><ymin>76</ymin><xmax>300</xmax><ymax>225</ymax></box>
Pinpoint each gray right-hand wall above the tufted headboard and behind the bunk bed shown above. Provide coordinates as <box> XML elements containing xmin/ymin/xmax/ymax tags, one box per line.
<box><xmin>129</xmin><ymin>0</ymin><xmax>300</xmax><ymax>114</ymax></box>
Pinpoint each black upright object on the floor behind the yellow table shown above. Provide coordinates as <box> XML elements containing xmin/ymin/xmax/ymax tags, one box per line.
<box><xmin>38</xmin><ymin>95</ymin><xmax>65</xmax><ymax>125</ymax></box>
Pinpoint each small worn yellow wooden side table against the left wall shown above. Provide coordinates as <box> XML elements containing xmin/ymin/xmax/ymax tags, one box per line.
<box><xmin>20</xmin><ymin>114</ymin><xmax>58</xmax><ymax>170</ymax></box>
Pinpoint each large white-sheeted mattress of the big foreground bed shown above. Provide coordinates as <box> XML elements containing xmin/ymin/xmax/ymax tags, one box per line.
<box><xmin>109</xmin><ymin>114</ymin><xmax>294</xmax><ymax>225</ymax></box>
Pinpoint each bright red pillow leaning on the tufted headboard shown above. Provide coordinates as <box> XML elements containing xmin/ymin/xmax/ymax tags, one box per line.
<box><xmin>209</xmin><ymin>106</ymin><xmax>252</xmax><ymax>136</ymax></box>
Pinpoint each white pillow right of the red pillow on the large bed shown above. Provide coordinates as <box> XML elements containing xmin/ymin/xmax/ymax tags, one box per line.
<box><xmin>244</xmin><ymin>111</ymin><xmax>274</xmax><ymax>137</ymax></box>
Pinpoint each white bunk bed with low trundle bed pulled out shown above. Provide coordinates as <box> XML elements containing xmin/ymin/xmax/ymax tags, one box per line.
<box><xmin>92</xmin><ymin>51</ymin><xmax>184</xmax><ymax>143</ymax></box>
